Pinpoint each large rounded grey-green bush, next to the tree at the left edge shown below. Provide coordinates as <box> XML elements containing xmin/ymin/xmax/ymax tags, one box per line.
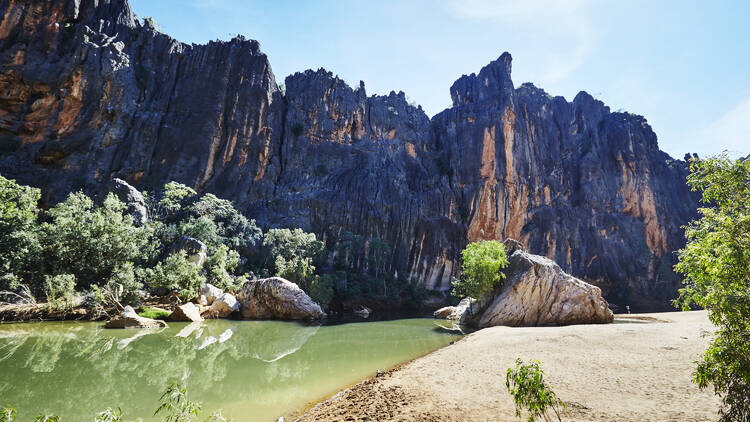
<box><xmin>41</xmin><ymin>192</ymin><xmax>153</xmax><ymax>288</ymax></box>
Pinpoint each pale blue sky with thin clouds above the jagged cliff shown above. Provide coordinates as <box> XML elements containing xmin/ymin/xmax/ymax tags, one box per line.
<box><xmin>130</xmin><ymin>0</ymin><xmax>750</xmax><ymax>158</ymax></box>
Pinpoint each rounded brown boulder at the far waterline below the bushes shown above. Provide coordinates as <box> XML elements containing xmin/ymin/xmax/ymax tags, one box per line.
<box><xmin>238</xmin><ymin>277</ymin><xmax>326</xmax><ymax>320</ymax></box>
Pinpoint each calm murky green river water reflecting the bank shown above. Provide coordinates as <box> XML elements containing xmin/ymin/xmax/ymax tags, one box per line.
<box><xmin>0</xmin><ymin>319</ymin><xmax>457</xmax><ymax>422</ymax></box>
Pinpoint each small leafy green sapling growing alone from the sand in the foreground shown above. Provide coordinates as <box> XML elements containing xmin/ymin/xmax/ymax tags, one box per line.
<box><xmin>505</xmin><ymin>359</ymin><xmax>565</xmax><ymax>422</ymax></box>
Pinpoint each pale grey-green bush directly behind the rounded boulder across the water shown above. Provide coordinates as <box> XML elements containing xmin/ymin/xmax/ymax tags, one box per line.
<box><xmin>263</xmin><ymin>229</ymin><xmax>325</xmax><ymax>286</ymax></box>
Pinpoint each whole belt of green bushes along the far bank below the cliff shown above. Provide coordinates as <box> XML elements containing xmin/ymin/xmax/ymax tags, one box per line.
<box><xmin>0</xmin><ymin>176</ymin><xmax>428</xmax><ymax>320</ymax></box>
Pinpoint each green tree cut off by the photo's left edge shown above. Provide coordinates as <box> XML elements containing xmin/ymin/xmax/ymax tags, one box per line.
<box><xmin>0</xmin><ymin>176</ymin><xmax>41</xmax><ymax>288</ymax></box>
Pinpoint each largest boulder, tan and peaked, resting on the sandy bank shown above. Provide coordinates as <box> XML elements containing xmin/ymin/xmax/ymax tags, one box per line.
<box><xmin>478</xmin><ymin>249</ymin><xmax>614</xmax><ymax>327</ymax></box>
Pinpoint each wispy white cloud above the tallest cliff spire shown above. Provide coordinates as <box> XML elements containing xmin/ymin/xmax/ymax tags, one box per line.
<box><xmin>450</xmin><ymin>0</ymin><xmax>598</xmax><ymax>84</ymax></box>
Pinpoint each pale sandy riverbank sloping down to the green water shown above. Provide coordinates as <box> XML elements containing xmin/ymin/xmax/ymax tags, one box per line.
<box><xmin>299</xmin><ymin>311</ymin><xmax>719</xmax><ymax>422</ymax></box>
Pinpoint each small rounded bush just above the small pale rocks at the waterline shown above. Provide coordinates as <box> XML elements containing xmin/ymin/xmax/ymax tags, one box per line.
<box><xmin>148</xmin><ymin>252</ymin><xmax>206</xmax><ymax>299</ymax></box>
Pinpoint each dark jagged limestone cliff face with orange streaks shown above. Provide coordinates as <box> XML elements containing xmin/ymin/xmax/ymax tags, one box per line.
<box><xmin>0</xmin><ymin>0</ymin><xmax>696</xmax><ymax>310</ymax></box>
